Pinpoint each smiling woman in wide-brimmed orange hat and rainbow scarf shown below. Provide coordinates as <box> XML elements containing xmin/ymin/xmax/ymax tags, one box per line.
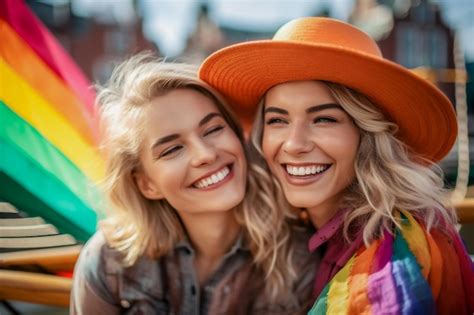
<box><xmin>200</xmin><ymin>18</ymin><xmax>474</xmax><ymax>314</ymax></box>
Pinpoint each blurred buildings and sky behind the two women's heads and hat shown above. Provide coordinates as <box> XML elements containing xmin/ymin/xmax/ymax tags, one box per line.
<box><xmin>27</xmin><ymin>0</ymin><xmax>474</xmax><ymax>183</ymax></box>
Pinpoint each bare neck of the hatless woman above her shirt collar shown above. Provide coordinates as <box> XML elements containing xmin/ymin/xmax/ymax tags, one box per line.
<box><xmin>181</xmin><ymin>211</ymin><xmax>239</xmax><ymax>285</ymax></box>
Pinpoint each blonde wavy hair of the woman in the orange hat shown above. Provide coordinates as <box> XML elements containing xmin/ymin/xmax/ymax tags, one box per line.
<box><xmin>251</xmin><ymin>81</ymin><xmax>457</xmax><ymax>245</ymax></box>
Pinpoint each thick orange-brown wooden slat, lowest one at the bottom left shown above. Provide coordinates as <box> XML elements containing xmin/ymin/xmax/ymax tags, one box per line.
<box><xmin>0</xmin><ymin>270</ymin><xmax>72</xmax><ymax>307</ymax></box>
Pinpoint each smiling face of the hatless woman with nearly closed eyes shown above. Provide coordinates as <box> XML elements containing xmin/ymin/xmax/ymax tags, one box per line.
<box><xmin>135</xmin><ymin>89</ymin><xmax>247</xmax><ymax>213</ymax></box>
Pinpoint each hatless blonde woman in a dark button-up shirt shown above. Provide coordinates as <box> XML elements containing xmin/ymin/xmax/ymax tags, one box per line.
<box><xmin>71</xmin><ymin>54</ymin><xmax>315</xmax><ymax>314</ymax></box>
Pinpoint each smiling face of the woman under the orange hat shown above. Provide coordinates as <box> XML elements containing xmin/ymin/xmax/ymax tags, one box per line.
<box><xmin>262</xmin><ymin>81</ymin><xmax>360</xmax><ymax>227</ymax></box>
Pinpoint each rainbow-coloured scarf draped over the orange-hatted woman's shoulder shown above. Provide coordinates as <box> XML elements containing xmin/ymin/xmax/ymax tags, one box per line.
<box><xmin>308</xmin><ymin>211</ymin><xmax>474</xmax><ymax>315</ymax></box>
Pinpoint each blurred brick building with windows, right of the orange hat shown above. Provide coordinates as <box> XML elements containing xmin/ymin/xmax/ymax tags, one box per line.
<box><xmin>350</xmin><ymin>0</ymin><xmax>474</xmax><ymax>185</ymax></box>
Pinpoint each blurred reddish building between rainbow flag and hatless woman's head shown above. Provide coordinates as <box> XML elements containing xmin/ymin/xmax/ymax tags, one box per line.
<box><xmin>27</xmin><ymin>0</ymin><xmax>156</xmax><ymax>82</ymax></box>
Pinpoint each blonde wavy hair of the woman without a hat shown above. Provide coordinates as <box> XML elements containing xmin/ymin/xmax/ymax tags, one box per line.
<box><xmin>96</xmin><ymin>53</ymin><xmax>296</xmax><ymax>298</ymax></box>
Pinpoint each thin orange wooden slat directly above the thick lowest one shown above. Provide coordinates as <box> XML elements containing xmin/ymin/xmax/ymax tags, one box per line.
<box><xmin>0</xmin><ymin>245</ymin><xmax>82</xmax><ymax>271</ymax></box>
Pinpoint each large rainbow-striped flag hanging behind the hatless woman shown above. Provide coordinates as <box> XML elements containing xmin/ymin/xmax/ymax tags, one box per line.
<box><xmin>0</xmin><ymin>0</ymin><xmax>103</xmax><ymax>240</ymax></box>
